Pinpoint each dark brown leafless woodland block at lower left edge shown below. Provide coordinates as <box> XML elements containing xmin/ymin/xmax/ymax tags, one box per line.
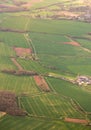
<box><xmin>0</xmin><ymin>91</ymin><xmax>27</xmax><ymax>116</ymax></box>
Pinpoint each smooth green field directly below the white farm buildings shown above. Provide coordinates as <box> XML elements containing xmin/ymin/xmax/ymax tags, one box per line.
<box><xmin>48</xmin><ymin>78</ymin><xmax>91</xmax><ymax>112</ymax></box>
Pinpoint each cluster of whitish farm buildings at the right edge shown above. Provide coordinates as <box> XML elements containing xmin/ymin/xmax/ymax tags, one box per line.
<box><xmin>76</xmin><ymin>76</ymin><xmax>91</xmax><ymax>86</ymax></box>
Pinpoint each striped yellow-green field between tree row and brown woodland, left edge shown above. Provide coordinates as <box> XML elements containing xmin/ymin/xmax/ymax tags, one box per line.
<box><xmin>0</xmin><ymin>74</ymin><xmax>39</xmax><ymax>94</ymax></box>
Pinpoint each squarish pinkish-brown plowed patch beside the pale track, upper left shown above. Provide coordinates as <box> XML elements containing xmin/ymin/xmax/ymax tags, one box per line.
<box><xmin>14</xmin><ymin>47</ymin><xmax>32</xmax><ymax>56</ymax></box>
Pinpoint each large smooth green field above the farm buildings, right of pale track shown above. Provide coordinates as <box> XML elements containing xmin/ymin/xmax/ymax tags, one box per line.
<box><xmin>27</xmin><ymin>33</ymin><xmax>91</xmax><ymax>75</ymax></box>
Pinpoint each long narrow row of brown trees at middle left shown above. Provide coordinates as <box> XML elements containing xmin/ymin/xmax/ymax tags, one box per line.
<box><xmin>1</xmin><ymin>69</ymin><xmax>38</xmax><ymax>76</ymax></box>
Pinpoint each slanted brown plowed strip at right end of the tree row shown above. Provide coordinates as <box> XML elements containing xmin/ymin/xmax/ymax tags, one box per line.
<box><xmin>34</xmin><ymin>76</ymin><xmax>50</xmax><ymax>92</ymax></box>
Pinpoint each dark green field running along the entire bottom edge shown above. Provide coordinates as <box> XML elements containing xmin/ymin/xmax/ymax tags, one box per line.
<box><xmin>0</xmin><ymin>116</ymin><xmax>90</xmax><ymax>130</ymax></box>
